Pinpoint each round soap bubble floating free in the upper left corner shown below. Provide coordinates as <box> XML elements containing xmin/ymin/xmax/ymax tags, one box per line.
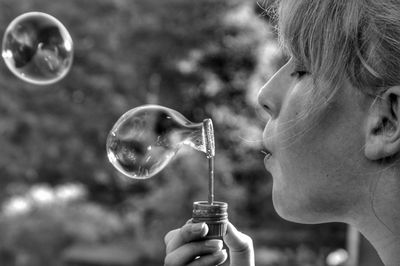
<box><xmin>2</xmin><ymin>12</ymin><xmax>73</xmax><ymax>85</ymax></box>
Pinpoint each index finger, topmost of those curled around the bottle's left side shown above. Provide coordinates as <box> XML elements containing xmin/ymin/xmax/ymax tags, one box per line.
<box><xmin>164</xmin><ymin>223</ymin><xmax>208</xmax><ymax>254</ymax></box>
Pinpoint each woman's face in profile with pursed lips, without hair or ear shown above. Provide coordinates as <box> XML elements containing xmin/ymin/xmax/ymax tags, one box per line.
<box><xmin>258</xmin><ymin>59</ymin><xmax>370</xmax><ymax>223</ymax></box>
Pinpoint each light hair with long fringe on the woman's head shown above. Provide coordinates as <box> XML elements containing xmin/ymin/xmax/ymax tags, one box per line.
<box><xmin>277</xmin><ymin>0</ymin><xmax>400</xmax><ymax>95</ymax></box>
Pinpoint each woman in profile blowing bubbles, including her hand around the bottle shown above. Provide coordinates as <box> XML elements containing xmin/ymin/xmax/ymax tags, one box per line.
<box><xmin>165</xmin><ymin>0</ymin><xmax>400</xmax><ymax>266</ymax></box>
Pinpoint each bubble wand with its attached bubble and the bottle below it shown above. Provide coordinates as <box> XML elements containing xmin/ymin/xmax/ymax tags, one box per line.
<box><xmin>107</xmin><ymin>105</ymin><xmax>228</xmax><ymax>238</ymax></box>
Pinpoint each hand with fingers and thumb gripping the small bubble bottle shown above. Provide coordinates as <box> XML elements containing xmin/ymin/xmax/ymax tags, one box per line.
<box><xmin>164</xmin><ymin>222</ymin><xmax>254</xmax><ymax>266</ymax></box>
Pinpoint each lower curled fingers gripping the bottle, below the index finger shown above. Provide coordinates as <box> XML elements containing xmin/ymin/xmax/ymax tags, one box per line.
<box><xmin>164</xmin><ymin>239</ymin><xmax>226</xmax><ymax>266</ymax></box>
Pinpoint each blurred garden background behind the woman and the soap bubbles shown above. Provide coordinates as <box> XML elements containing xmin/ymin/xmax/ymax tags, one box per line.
<box><xmin>0</xmin><ymin>0</ymin><xmax>360</xmax><ymax>266</ymax></box>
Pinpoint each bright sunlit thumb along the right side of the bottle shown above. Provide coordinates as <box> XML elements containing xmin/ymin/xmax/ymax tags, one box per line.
<box><xmin>224</xmin><ymin>222</ymin><xmax>255</xmax><ymax>266</ymax></box>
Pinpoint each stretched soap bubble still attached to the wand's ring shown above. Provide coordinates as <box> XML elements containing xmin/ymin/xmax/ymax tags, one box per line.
<box><xmin>107</xmin><ymin>105</ymin><xmax>215</xmax><ymax>179</ymax></box>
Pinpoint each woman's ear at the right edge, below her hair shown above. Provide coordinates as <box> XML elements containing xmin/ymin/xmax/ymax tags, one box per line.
<box><xmin>364</xmin><ymin>86</ymin><xmax>400</xmax><ymax>160</ymax></box>
